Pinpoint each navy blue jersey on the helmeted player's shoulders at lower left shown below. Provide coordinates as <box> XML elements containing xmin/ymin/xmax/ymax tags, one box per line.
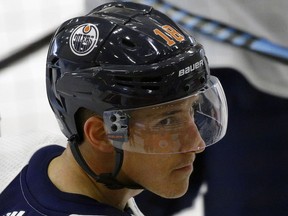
<box><xmin>0</xmin><ymin>145</ymin><xmax>142</xmax><ymax>216</ymax></box>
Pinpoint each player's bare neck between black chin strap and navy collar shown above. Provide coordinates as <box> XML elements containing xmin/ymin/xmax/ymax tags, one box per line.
<box><xmin>48</xmin><ymin>146</ymin><xmax>142</xmax><ymax>210</ymax></box>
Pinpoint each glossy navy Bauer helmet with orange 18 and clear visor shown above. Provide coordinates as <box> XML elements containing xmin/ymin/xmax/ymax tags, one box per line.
<box><xmin>46</xmin><ymin>2</ymin><xmax>227</xmax><ymax>187</ymax></box>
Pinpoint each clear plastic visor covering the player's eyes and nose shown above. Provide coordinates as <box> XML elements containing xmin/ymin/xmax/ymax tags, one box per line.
<box><xmin>103</xmin><ymin>76</ymin><xmax>228</xmax><ymax>154</ymax></box>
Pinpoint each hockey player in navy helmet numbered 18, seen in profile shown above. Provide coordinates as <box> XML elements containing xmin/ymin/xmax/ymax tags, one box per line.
<box><xmin>0</xmin><ymin>2</ymin><xmax>227</xmax><ymax>216</ymax></box>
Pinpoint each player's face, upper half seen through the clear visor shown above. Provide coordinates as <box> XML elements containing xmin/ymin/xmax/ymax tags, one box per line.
<box><xmin>117</xmin><ymin>98</ymin><xmax>205</xmax><ymax>198</ymax></box>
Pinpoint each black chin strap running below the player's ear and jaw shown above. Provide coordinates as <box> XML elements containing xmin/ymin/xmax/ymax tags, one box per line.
<box><xmin>68</xmin><ymin>135</ymin><xmax>144</xmax><ymax>190</ymax></box>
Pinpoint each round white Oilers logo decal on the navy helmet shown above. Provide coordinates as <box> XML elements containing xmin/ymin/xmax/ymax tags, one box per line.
<box><xmin>69</xmin><ymin>23</ymin><xmax>99</xmax><ymax>56</ymax></box>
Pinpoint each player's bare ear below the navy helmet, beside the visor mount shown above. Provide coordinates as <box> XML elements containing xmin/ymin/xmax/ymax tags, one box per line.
<box><xmin>83</xmin><ymin>116</ymin><xmax>114</xmax><ymax>153</ymax></box>
